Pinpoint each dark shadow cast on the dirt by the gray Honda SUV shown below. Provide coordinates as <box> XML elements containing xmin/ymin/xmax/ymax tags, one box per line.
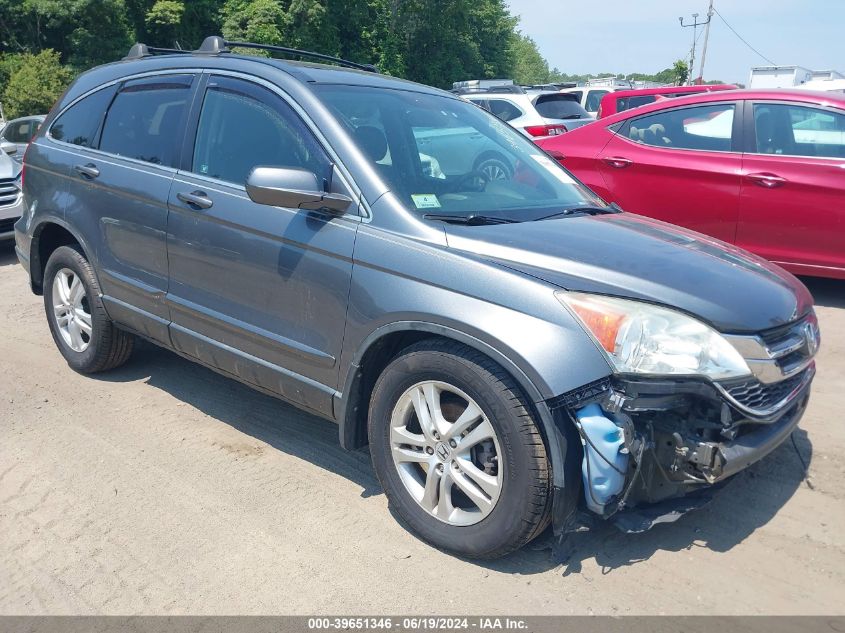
<box><xmin>90</xmin><ymin>343</ymin><xmax>812</xmax><ymax>574</ymax></box>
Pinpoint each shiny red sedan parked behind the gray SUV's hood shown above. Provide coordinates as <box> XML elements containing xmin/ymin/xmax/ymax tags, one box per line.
<box><xmin>539</xmin><ymin>90</ymin><xmax>845</xmax><ymax>279</ymax></box>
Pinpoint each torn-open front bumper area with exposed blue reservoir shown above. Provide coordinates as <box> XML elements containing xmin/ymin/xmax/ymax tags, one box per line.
<box><xmin>549</xmin><ymin>363</ymin><xmax>815</xmax><ymax>534</ymax></box>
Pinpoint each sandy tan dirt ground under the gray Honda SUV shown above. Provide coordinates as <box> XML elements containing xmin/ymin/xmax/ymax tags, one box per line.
<box><xmin>0</xmin><ymin>243</ymin><xmax>845</xmax><ymax>615</ymax></box>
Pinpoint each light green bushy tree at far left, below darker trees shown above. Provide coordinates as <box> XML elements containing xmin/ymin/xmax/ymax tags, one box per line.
<box><xmin>3</xmin><ymin>49</ymin><xmax>73</xmax><ymax>118</ymax></box>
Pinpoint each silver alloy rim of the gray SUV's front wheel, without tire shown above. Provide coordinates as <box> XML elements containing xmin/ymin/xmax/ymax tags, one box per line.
<box><xmin>390</xmin><ymin>380</ymin><xmax>504</xmax><ymax>526</ymax></box>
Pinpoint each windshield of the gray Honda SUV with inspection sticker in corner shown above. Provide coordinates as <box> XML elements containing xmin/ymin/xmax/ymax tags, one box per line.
<box><xmin>315</xmin><ymin>84</ymin><xmax>603</xmax><ymax>220</ymax></box>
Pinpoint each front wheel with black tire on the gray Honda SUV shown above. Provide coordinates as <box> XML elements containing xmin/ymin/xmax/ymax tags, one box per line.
<box><xmin>369</xmin><ymin>340</ymin><xmax>551</xmax><ymax>559</ymax></box>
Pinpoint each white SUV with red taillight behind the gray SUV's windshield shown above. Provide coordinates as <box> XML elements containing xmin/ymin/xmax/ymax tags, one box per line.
<box><xmin>460</xmin><ymin>86</ymin><xmax>594</xmax><ymax>139</ymax></box>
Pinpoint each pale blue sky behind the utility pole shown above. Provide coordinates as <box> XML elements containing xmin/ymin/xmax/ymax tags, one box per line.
<box><xmin>508</xmin><ymin>0</ymin><xmax>845</xmax><ymax>83</ymax></box>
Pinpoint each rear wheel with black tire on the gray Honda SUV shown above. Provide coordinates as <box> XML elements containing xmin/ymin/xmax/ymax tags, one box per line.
<box><xmin>44</xmin><ymin>245</ymin><xmax>135</xmax><ymax>374</ymax></box>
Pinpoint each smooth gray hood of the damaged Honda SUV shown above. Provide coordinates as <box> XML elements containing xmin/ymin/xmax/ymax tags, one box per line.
<box><xmin>446</xmin><ymin>213</ymin><xmax>813</xmax><ymax>333</ymax></box>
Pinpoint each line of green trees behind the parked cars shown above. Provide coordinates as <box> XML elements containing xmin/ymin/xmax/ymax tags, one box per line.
<box><xmin>0</xmin><ymin>0</ymin><xmax>696</xmax><ymax>118</ymax></box>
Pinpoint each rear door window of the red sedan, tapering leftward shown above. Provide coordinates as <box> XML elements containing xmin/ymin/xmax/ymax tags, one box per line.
<box><xmin>622</xmin><ymin>103</ymin><xmax>736</xmax><ymax>152</ymax></box>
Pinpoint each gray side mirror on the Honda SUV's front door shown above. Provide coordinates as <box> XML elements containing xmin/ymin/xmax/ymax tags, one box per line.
<box><xmin>246</xmin><ymin>167</ymin><xmax>352</xmax><ymax>215</ymax></box>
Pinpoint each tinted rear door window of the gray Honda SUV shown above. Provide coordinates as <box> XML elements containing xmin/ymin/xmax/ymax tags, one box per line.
<box><xmin>100</xmin><ymin>75</ymin><xmax>193</xmax><ymax>167</ymax></box>
